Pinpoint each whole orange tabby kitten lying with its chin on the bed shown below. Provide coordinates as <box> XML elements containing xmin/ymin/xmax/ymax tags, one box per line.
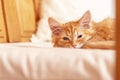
<box><xmin>48</xmin><ymin>11</ymin><xmax>115</xmax><ymax>49</ymax></box>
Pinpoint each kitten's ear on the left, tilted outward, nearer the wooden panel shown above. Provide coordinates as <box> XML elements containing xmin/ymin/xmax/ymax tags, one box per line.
<box><xmin>48</xmin><ymin>17</ymin><xmax>62</xmax><ymax>35</ymax></box>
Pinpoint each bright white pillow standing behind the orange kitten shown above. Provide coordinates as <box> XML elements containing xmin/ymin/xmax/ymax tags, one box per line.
<box><xmin>31</xmin><ymin>0</ymin><xmax>115</xmax><ymax>42</ymax></box>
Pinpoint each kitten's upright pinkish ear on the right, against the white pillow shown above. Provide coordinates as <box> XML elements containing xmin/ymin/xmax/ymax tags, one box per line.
<box><xmin>80</xmin><ymin>10</ymin><xmax>91</xmax><ymax>29</ymax></box>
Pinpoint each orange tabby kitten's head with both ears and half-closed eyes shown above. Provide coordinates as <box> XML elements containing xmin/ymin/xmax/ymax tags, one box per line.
<box><xmin>48</xmin><ymin>11</ymin><xmax>94</xmax><ymax>48</ymax></box>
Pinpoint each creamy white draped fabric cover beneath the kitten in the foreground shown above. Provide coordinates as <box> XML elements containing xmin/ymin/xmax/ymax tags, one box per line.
<box><xmin>0</xmin><ymin>43</ymin><xmax>115</xmax><ymax>80</ymax></box>
